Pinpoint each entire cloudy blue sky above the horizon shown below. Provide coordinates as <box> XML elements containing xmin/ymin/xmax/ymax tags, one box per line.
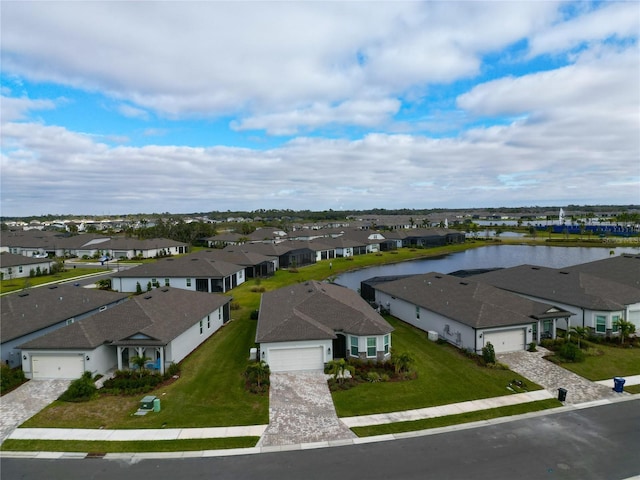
<box><xmin>0</xmin><ymin>0</ymin><xmax>640</xmax><ymax>217</ymax></box>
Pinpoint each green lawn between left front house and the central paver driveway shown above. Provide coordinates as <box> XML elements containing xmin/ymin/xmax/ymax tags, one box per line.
<box><xmin>22</xmin><ymin>319</ymin><xmax>269</xmax><ymax>429</ymax></box>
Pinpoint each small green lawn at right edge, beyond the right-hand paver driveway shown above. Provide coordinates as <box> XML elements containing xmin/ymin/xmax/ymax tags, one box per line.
<box><xmin>561</xmin><ymin>343</ymin><xmax>640</xmax><ymax>381</ymax></box>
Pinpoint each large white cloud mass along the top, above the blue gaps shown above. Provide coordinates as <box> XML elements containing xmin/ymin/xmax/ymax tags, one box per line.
<box><xmin>2</xmin><ymin>2</ymin><xmax>556</xmax><ymax>128</ymax></box>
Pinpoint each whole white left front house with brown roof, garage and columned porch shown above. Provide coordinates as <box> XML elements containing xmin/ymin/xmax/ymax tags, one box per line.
<box><xmin>20</xmin><ymin>288</ymin><xmax>231</xmax><ymax>379</ymax></box>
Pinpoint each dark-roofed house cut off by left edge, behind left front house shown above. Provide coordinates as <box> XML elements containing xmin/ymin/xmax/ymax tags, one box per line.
<box><xmin>0</xmin><ymin>285</ymin><xmax>127</xmax><ymax>367</ymax></box>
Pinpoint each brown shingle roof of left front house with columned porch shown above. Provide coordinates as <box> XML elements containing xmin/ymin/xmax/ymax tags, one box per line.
<box><xmin>21</xmin><ymin>287</ymin><xmax>231</xmax><ymax>349</ymax></box>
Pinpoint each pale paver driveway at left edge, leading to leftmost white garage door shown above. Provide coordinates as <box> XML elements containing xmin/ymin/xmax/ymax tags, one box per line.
<box><xmin>0</xmin><ymin>380</ymin><xmax>71</xmax><ymax>442</ymax></box>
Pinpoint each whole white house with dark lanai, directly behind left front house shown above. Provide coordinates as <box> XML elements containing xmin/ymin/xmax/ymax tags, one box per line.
<box><xmin>111</xmin><ymin>254</ymin><xmax>246</xmax><ymax>293</ymax></box>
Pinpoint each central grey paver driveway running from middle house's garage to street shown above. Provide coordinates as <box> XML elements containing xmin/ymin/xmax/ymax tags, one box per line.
<box><xmin>259</xmin><ymin>372</ymin><xmax>356</xmax><ymax>447</ymax></box>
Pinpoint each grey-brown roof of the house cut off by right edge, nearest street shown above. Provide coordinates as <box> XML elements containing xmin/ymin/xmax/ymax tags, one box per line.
<box><xmin>472</xmin><ymin>265</ymin><xmax>640</xmax><ymax>311</ymax></box>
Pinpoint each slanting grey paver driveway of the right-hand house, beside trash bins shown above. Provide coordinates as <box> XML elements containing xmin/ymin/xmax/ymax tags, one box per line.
<box><xmin>496</xmin><ymin>347</ymin><xmax>623</xmax><ymax>404</ymax></box>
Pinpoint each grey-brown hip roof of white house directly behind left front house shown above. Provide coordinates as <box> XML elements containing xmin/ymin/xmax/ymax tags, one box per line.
<box><xmin>113</xmin><ymin>254</ymin><xmax>244</xmax><ymax>278</ymax></box>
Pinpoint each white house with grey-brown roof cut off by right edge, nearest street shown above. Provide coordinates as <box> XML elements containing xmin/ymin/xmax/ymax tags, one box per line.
<box><xmin>471</xmin><ymin>259</ymin><xmax>640</xmax><ymax>336</ymax></box>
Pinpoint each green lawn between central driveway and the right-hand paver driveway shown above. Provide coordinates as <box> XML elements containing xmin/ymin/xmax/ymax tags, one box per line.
<box><xmin>333</xmin><ymin>317</ymin><xmax>541</xmax><ymax>417</ymax></box>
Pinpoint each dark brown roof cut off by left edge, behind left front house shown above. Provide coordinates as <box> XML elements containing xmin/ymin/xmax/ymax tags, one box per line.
<box><xmin>0</xmin><ymin>285</ymin><xmax>128</xmax><ymax>342</ymax></box>
